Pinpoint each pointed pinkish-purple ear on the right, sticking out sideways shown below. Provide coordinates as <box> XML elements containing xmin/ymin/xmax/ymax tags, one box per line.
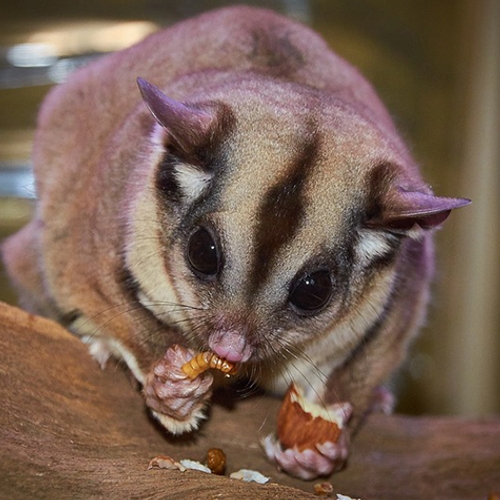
<box><xmin>366</xmin><ymin>187</ymin><xmax>471</xmax><ymax>232</ymax></box>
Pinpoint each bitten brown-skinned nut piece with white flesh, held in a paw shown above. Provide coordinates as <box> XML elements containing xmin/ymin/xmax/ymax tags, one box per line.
<box><xmin>278</xmin><ymin>383</ymin><xmax>349</xmax><ymax>451</ymax></box>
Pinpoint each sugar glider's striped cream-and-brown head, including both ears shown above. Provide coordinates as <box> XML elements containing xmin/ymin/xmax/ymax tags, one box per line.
<box><xmin>127</xmin><ymin>75</ymin><xmax>467</xmax><ymax>372</ymax></box>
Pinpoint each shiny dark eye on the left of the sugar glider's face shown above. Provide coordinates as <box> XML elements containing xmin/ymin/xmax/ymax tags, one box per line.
<box><xmin>187</xmin><ymin>227</ymin><xmax>220</xmax><ymax>278</ymax></box>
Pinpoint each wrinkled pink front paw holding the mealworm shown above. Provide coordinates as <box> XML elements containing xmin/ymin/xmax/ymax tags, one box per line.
<box><xmin>143</xmin><ymin>345</ymin><xmax>213</xmax><ymax>434</ymax></box>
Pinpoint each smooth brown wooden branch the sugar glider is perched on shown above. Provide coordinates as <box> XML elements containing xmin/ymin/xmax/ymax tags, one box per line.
<box><xmin>0</xmin><ymin>303</ymin><xmax>500</xmax><ymax>500</ymax></box>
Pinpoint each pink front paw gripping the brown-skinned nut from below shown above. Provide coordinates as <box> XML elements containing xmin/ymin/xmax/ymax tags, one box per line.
<box><xmin>263</xmin><ymin>432</ymin><xmax>349</xmax><ymax>480</ymax></box>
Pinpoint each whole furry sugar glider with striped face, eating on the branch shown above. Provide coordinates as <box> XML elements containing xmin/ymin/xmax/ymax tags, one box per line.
<box><xmin>3</xmin><ymin>7</ymin><xmax>466</xmax><ymax>477</ymax></box>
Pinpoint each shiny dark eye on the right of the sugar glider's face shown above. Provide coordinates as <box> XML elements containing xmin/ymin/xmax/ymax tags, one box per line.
<box><xmin>288</xmin><ymin>271</ymin><xmax>332</xmax><ymax>313</ymax></box>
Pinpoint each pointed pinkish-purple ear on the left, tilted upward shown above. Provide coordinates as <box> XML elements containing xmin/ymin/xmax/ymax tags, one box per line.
<box><xmin>137</xmin><ymin>78</ymin><xmax>218</xmax><ymax>156</ymax></box>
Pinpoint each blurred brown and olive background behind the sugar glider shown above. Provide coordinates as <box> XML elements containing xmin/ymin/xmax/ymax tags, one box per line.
<box><xmin>0</xmin><ymin>0</ymin><xmax>500</xmax><ymax>416</ymax></box>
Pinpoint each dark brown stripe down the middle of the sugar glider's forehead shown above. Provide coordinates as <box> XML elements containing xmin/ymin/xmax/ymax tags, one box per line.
<box><xmin>250</xmin><ymin>135</ymin><xmax>319</xmax><ymax>292</ymax></box>
